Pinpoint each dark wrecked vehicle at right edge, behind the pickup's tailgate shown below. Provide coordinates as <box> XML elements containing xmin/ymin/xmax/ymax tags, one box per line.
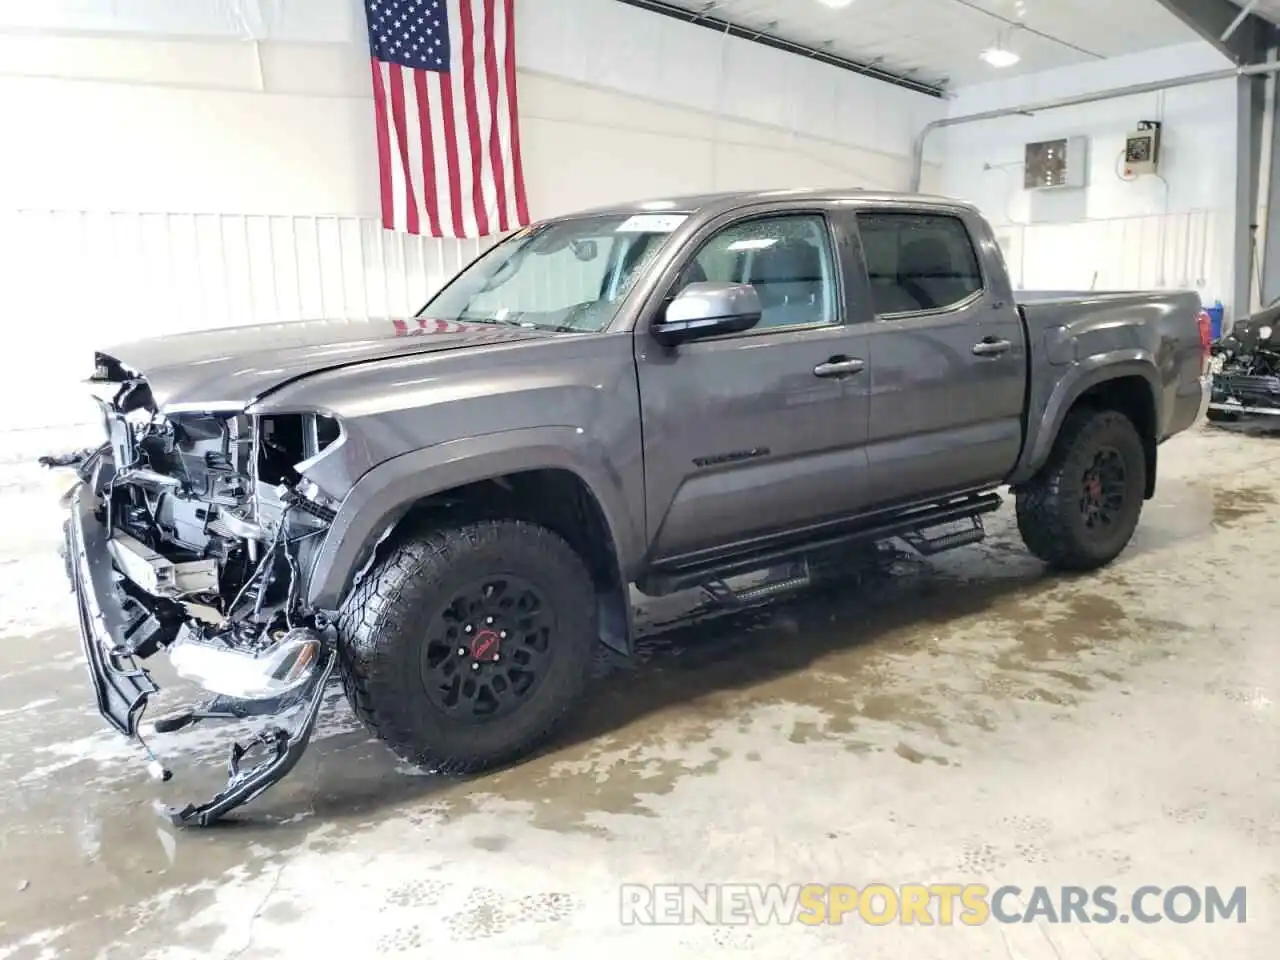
<box><xmin>1208</xmin><ymin>317</ymin><xmax>1280</xmax><ymax>420</ymax></box>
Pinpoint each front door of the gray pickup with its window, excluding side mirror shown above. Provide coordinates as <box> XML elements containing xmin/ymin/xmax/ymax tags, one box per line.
<box><xmin>636</xmin><ymin>210</ymin><xmax>868</xmax><ymax>562</ymax></box>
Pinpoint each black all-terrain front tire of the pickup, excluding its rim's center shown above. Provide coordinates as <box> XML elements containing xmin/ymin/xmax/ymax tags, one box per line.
<box><xmin>338</xmin><ymin>520</ymin><xmax>599</xmax><ymax>773</ymax></box>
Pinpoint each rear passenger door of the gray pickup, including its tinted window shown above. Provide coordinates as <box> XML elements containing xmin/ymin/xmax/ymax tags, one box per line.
<box><xmin>856</xmin><ymin>207</ymin><xmax>1027</xmax><ymax>507</ymax></box>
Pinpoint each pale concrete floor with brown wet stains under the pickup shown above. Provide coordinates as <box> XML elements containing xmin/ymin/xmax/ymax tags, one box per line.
<box><xmin>0</xmin><ymin>428</ymin><xmax>1280</xmax><ymax>960</ymax></box>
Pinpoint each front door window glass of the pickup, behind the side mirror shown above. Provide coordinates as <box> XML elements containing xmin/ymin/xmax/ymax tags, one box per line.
<box><xmin>676</xmin><ymin>214</ymin><xmax>840</xmax><ymax>329</ymax></box>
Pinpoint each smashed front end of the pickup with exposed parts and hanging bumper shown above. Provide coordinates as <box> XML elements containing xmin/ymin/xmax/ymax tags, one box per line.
<box><xmin>42</xmin><ymin>355</ymin><xmax>340</xmax><ymax>824</ymax></box>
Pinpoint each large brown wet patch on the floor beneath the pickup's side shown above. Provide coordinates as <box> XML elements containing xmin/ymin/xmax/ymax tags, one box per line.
<box><xmin>384</xmin><ymin>537</ymin><xmax>1203</xmax><ymax>832</ymax></box>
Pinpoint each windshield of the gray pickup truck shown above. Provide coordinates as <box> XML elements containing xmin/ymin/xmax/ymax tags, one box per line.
<box><xmin>419</xmin><ymin>214</ymin><xmax>687</xmax><ymax>333</ymax></box>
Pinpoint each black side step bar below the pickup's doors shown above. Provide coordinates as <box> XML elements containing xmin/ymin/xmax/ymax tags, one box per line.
<box><xmin>636</xmin><ymin>493</ymin><xmax>1004</xmax><ymax>596</ymax></box>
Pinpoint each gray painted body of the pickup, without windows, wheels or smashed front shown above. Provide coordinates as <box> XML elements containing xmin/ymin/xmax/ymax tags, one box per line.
<box><xmin>92</xmin><ymin>191</ymin><xmax>1202</xmax><ymax>609</ymax></box>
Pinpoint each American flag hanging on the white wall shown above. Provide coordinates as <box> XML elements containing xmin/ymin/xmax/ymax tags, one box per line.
<box><xmin>364</xmin><ymin>0</ymin><xmax>529</xmax><ymax>237</ymax></box>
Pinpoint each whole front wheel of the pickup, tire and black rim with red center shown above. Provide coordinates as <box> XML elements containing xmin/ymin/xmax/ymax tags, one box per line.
<box><xmin>338</xmin><ymin>520</ymin><xmax>599</xmax><ymax>773</ymax></box>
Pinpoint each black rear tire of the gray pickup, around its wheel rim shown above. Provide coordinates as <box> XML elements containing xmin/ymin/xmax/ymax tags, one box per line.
<box><xmin>1015</xmin><ymin>407</ymin><xmax>1147</xmax><ymax>571</ymax></box>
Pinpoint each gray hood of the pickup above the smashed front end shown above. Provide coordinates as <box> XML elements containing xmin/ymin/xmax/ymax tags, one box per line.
<box><xmin>97</xmin><ymin>317</ymin><xmax>554</xmax><ymax>412</ymax></box>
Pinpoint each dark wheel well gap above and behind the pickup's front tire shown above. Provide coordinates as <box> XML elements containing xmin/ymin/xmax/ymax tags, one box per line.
<box><xmin>389</xmin><ymin>468</ymin><xmax>631</xmax><ymax>654</ymax></box>
